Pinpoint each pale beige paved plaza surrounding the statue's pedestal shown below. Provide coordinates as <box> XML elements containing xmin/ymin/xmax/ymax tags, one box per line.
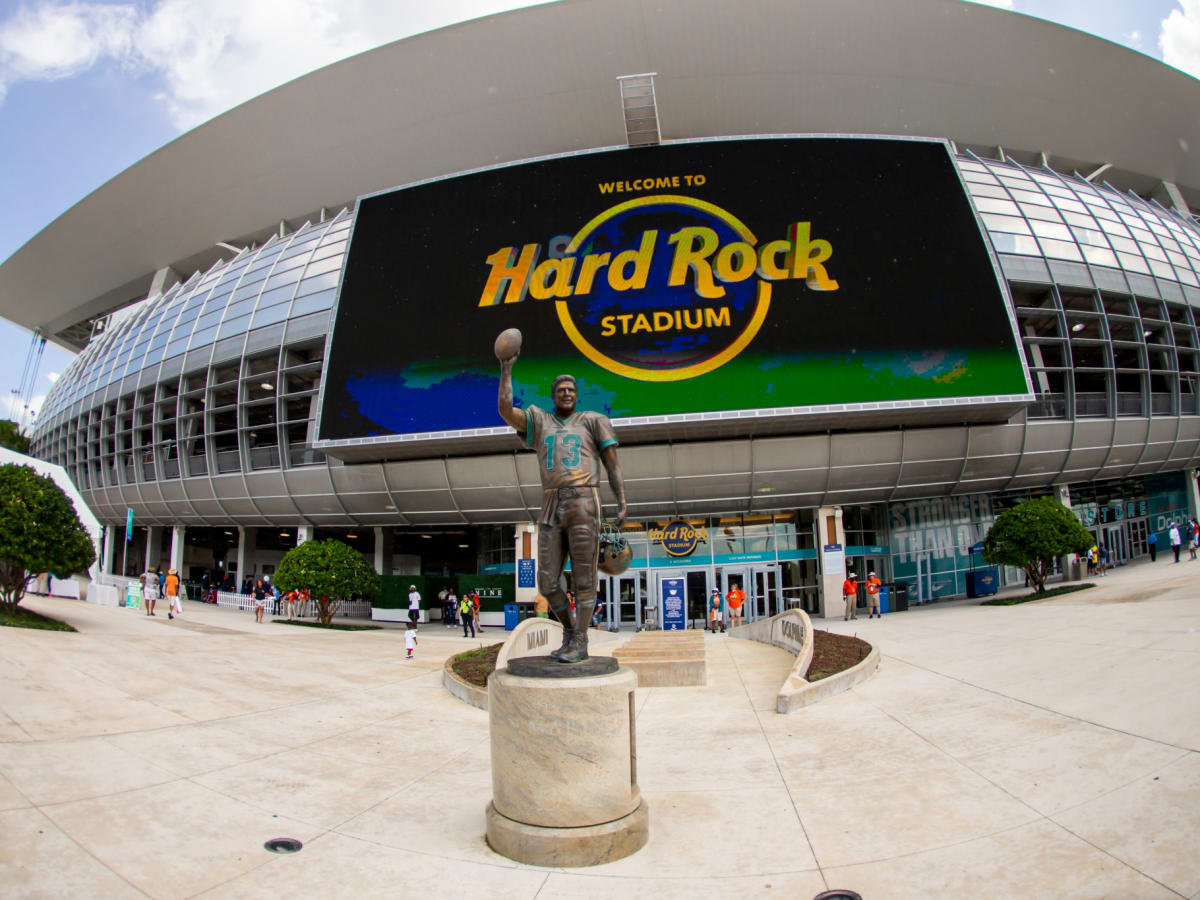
<box><xmin>0</xmin><ymin>562</ymin><xmax>1200</xmax><ymax>900</ymax></box>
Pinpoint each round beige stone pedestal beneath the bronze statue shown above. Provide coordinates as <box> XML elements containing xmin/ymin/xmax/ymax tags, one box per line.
<box><xmin>487</xmin><ymin>660</ymin><xmax>649</xmax><ymax>866</ymax></box>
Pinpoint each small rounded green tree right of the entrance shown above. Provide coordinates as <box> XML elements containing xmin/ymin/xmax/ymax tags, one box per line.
<box><xmin>983</xmin><ymin>497</ymin><xmax>1092</xmax><ymax>594</ymax></box>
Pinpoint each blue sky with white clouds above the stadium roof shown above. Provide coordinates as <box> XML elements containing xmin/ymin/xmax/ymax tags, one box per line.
<box><xmin>0</xmin><ymin>0</ymin><xmax>1200</xmax><ymax>421</ymax></box>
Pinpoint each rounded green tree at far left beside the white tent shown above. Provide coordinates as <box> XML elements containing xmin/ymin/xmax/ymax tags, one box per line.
<box><xmin>0</xmin><ymin>463</ymin><xmax>96</xmax><ymax>613</ymax></box>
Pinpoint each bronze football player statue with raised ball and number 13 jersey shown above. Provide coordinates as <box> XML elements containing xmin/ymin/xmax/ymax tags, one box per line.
<box><xmin>496</xmin><ymin>329</ymin><xmax>628</xmax><ymax>662</ymax></box>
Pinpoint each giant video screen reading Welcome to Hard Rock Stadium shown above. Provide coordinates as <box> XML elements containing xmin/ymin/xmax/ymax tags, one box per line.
<box><xmin>319</xmin><ymin>137</ymin><xmax>1030</xmax><ymax>446</ymax></box>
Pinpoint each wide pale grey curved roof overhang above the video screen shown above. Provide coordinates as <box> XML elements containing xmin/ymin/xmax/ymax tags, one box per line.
<box><xmin>0</xmin><ymin>0</ymin><xmax>1200</xmax><ymax>348</ymax></box>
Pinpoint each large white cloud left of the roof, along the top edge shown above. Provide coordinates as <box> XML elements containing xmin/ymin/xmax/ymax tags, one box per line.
<box><xmin>0</xmin><ymin>0</ymin><xmax>554</xmax><ymax>128</ymax></box>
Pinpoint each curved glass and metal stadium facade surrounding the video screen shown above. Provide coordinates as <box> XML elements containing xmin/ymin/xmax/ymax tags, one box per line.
<box><xmin>25</xmin><ymin>154</ymin><xmax>1200</xmax><ymax>624</ymax></box>
